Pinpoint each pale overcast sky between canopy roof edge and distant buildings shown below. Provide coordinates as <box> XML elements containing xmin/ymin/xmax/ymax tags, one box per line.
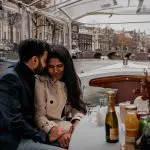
<box><xmin>78</xmin><ymin>15</ymin><xmax>150</xmax><ymax>35</ymax></box>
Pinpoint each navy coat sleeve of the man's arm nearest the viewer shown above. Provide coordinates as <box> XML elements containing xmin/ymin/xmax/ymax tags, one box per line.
<box><xmin>0</xmin><ymin>73</ymin><xmax>43</xmax><ymax>142</ymax></box>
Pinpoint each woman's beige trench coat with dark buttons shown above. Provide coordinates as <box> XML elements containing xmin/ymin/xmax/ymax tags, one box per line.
<box><xmin>35</xmin><ymin>76</ymin><xmax>84</xmax><ymax>133</ymax></box>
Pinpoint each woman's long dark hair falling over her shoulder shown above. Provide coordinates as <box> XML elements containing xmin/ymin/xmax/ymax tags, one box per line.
<box><xmin>47</xmin><ymin>45</ymin><xmax>86</xmax><ymax>113</ymax></box>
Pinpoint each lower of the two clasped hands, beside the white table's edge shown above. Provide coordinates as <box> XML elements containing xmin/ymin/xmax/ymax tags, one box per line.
<box><xmin>58</xmin><ymin>133</ymin><xmax>71</xmax><ymax>148</ymax></box>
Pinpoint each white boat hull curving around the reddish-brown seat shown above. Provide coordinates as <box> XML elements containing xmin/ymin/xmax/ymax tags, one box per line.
<box><xmin>79</xmin><ymin>62</ymin><xmax>150</xmax><ymax>103</ymax></box>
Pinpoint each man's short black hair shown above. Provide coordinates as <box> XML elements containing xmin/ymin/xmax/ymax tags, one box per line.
<box><xmin>17</xmin><ymin>39</ymin><xmax>49</xmax><ymax>62</ymax></box>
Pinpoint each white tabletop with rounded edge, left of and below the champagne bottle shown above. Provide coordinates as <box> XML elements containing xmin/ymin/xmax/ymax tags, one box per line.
<box><xmin>69</xmin><ymin>117</ymin><xmax>120</xmax><ymax>150</ymax></box>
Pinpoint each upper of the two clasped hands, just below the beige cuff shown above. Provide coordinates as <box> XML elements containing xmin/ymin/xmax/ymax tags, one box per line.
<box><xmin>49</xmin><ymin>126</ymin><xmax>65</xmax><ymax>142</ymax></box>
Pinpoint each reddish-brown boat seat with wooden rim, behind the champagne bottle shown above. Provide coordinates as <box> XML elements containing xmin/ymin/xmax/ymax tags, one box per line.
<box><xmin>89</xmin><ymin>75</ymin><xmax>150</xmax><ymax>104</ymax></box>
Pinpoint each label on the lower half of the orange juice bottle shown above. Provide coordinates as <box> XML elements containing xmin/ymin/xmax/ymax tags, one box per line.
<box><xmin>125</xmin><ymin>129</ymin><xmax>138</xmax><ymax>143</ymax></box>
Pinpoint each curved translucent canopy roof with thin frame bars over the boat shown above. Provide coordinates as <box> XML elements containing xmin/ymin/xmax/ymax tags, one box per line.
<box><xmin>27</xmin><ymin>0</ymin><xmax>150</xmax><ymax>22</ymax></box>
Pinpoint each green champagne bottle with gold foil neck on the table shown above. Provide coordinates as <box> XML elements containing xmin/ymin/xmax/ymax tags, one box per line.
<box><xmin>105</xmin><ymin>91</ymin><xmax>119</xmax><ymax>143</ymax></box>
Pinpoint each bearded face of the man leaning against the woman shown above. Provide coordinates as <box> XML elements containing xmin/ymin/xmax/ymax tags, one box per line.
<box><xmin>34</xmin><ymin>51</ymin><xmax>48</xmax><ymax>74</ymax></box>
